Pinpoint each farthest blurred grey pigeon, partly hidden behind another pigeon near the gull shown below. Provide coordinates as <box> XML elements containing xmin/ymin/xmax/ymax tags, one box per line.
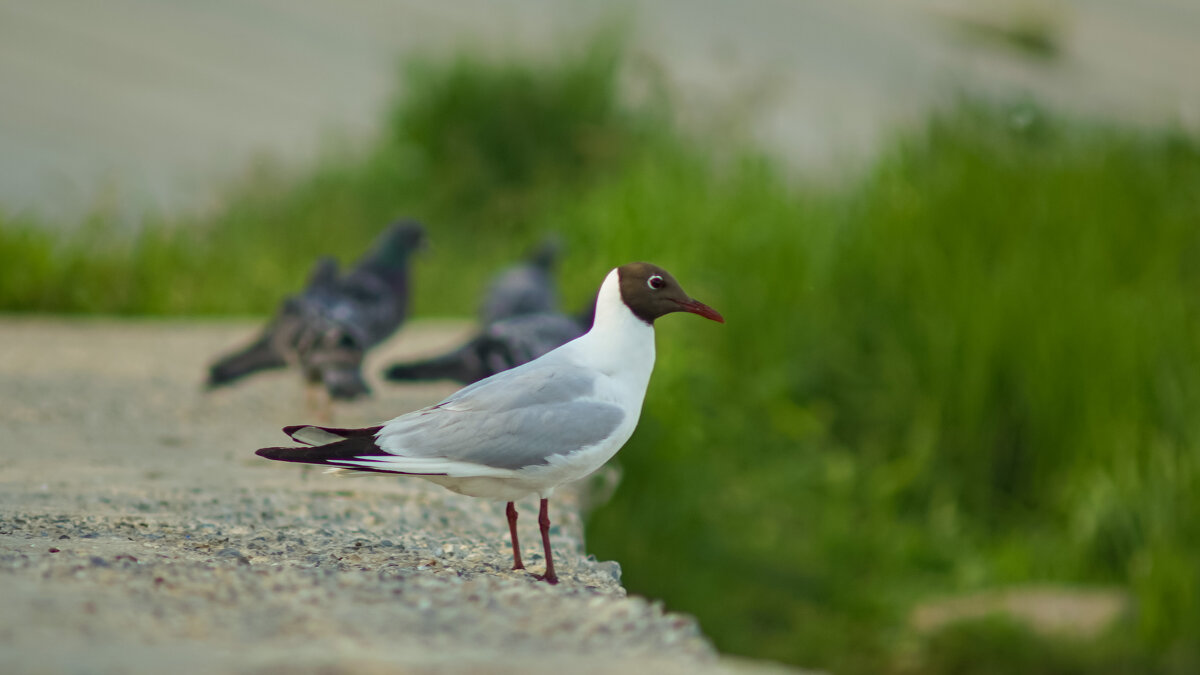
<box><xmin>479</xmin><ymin>238</ymin><xmax>562</xmax><ymax>325</ymax></box>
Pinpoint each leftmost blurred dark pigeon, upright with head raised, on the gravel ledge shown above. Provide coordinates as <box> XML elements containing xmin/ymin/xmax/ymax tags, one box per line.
<box><xmin>208</xmin><ymin>222</ymin><xmax>425</xmax><ymax>399</ymax></box>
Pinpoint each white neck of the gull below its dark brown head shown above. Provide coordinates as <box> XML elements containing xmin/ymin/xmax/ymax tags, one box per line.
<box><xmin>576</xmin><ymin>269</ymin><xmax>654</xmax><ymax>384</ymax></box>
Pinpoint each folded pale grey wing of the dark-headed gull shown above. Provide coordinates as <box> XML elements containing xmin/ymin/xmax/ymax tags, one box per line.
<box><xmin>377</xmin><ymin>363</ymin><xmax>625</xmax><ymax>470</ymax></box>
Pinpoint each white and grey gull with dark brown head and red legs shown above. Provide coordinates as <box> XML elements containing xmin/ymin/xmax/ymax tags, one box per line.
<box><xmin>257</xmin><ymin>262</ymin><xmax>725</xmax><ymax>584</ymax></box>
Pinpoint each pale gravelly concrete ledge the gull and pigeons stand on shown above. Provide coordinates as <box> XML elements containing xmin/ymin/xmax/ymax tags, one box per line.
<box><xmin>0</xmin><ymin>318</ymin><xmax>775</xmax><ymax>674</ymax></box>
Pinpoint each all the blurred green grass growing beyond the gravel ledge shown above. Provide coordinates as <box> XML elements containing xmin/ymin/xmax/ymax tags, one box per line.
<box><xmin>0</xmin><ymin>38</ymin><xmax>1200</xmax><ymax>674</ymax></box>
